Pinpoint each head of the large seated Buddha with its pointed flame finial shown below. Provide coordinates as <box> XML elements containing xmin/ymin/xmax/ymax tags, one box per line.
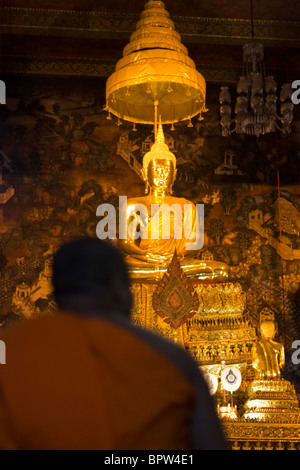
<box><xmin>142</xmin><ymin>125</ymin><xmax>177</xmax><ymax>194</ymax></box>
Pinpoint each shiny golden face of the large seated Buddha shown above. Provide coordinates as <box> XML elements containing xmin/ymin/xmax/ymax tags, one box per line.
<box><xmin>148</xmin><ymin>158</ymin><xmax>174</xmax><ymax>192</ymax></box>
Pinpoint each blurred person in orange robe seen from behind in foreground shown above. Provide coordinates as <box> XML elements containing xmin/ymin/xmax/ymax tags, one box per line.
<box><xmin>0</xmin><ymin>239</ymin><xmax>225</xmax><ymax>450</ymax></box>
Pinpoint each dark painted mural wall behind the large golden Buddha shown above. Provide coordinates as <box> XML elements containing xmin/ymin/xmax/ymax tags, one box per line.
<box><xmin>0</xmin><ymin>77</ymin><xmax>300</xmax><ymax>378</ymax></box>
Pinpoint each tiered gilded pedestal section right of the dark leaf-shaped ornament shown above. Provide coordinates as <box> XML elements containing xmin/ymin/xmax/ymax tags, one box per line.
<box><xmin>186</xmin><ymin>282</ymin><xmax>256</xmax><ymax>376</ymax></box>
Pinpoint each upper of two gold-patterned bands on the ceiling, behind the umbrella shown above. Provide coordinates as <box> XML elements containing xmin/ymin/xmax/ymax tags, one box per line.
<box><xmin>1</xmin><ymin>6</ymin><xmax>299</xmax><ymax>46</ymax></box>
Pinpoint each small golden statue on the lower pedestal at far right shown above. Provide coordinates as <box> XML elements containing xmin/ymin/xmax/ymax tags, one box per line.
<box><xmin>252</xmin><ymin>309</ymin><xmax>285</xmax><ymax>380</ymax></box>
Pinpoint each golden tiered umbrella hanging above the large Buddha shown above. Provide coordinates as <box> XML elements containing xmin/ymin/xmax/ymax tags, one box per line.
<box><xmin>106</xmin><ymin>0</ymin><xmax>206</xmax><ymax>130</ymax></box>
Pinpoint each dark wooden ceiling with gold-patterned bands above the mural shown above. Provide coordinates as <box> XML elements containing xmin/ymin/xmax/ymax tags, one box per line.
<box><xmin>0</xmin><ymin>0</ymin><xmax>300</xmax><ymax>84</ymax></box>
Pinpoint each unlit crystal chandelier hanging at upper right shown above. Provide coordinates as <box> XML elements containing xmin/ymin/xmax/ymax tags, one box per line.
<box><xmin>219</xmin><ymin>0</ymin><xmax>294</xmax><ymax>137</ymax></box>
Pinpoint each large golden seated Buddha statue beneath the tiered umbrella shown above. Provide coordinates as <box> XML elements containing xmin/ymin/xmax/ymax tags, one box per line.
<box><xmin>119</xmin><ymin>125</ymin><xmax>228</xmax><ymax>279</ymax></box>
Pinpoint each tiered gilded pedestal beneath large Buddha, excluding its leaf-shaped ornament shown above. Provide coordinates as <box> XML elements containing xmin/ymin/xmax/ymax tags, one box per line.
<box><xmin>132</xmin><ymin>280</ymin><xmax>256</xmax><ymax>375</ymax></box>
